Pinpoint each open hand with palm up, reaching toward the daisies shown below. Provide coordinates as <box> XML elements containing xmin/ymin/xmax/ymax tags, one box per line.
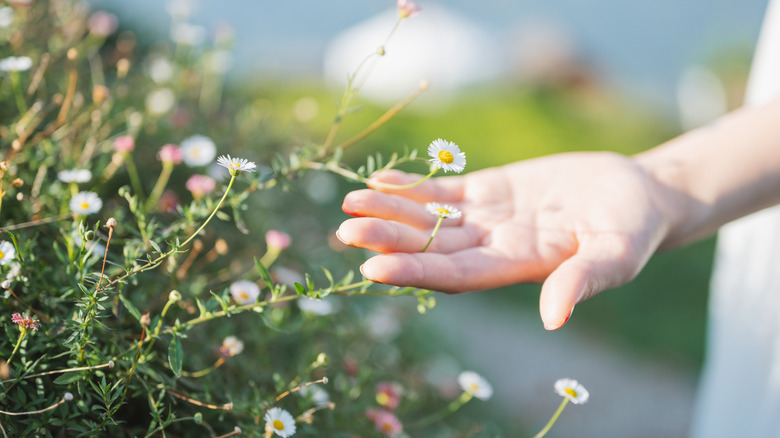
<box><xmin>337</xmin><ymin>152</ymin><xmax>671</xmax><ymax>330</ymax></box>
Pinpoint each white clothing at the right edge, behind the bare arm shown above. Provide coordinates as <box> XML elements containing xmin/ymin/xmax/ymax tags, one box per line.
<box><xmin>691</xmin><ymin>0</ymin><xmax>780</xmax><ymax>438</ymax></box>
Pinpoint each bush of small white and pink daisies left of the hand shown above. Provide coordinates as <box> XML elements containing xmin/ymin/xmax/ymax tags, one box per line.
<box><xmin>0</xmin><ymin>0</ymin><xmax>520</xmax><ymax>437</ymax></box>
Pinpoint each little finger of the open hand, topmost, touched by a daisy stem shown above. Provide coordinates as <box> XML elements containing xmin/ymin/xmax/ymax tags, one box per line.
<box><xmin>367</xmin><ymin>169</ymin><xmax>463</xmax><ymax>202</ymax></box>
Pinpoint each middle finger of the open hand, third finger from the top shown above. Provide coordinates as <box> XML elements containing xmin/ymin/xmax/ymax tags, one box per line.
<box><xmin>336</xmin><ymin>218</ymin><xmax>480</xmax><ymax>253</ymax></box>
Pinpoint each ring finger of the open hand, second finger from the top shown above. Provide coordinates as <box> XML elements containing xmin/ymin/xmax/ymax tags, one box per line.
<box><xmin>341</xmin><ymin>190</ymin><xmax>461</xmax><ymax>229</ymax></box>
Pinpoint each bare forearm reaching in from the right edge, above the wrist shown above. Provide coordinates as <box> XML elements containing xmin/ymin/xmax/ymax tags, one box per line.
<box><xmin>635</xmin><ymin>99</ymin><xmax>780</xmax><ymax>247</ymax></box>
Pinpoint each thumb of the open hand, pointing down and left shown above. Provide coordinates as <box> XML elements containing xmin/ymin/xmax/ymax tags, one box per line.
<box><xmin>539</xmin><ymin>236</ymin><xmax>636</xmax><ymax>330</ymax></box>
